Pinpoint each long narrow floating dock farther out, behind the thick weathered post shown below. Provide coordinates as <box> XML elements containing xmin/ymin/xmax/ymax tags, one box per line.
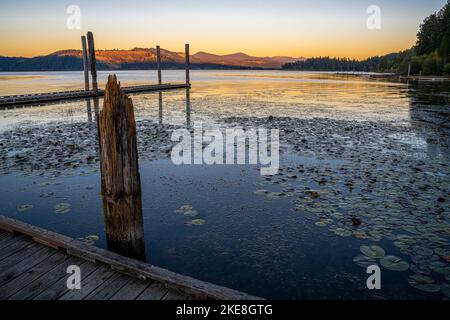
<box><xmin>0</xmin><ymin>83</ymin><xmax>189</xmax><ymax>107</ymax></box>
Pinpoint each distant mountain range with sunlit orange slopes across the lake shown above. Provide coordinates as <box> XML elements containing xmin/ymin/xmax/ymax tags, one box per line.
<box><xmin>0</xmin><ymin>48</ymin><xmax>303</xmax><ymax>71</ymax></box>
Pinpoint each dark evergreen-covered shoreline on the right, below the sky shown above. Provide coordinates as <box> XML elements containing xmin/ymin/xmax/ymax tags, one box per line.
<box><xmin>283</xmin><ymin>1</ymin><xmax>450</xmax><ymax>76</ymax></box>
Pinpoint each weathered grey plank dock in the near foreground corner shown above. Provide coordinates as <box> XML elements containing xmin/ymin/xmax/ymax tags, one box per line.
<box><xmin>0</xmin><ymin>216</ymin><xmax>261</xmax><ymax>300</ymax></box>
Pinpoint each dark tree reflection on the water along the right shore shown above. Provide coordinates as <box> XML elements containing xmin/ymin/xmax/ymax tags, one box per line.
<box><xmin>408</xmin><ymin>83</ymin><xmax>450</xmax><ymax>159</ymax></box>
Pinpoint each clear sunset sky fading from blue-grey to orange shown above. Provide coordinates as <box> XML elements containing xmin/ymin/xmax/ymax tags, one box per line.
<box><xmin>0</xmin><ymin>0</ymin><xmax>446</xmax><ymax>59</ymax></box>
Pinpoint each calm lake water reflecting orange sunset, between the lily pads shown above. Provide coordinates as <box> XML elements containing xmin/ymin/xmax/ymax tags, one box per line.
<box><xmin>0</xmin><ymin>71</ymin><xmax>450</xmax><ymax>299</ymax></box>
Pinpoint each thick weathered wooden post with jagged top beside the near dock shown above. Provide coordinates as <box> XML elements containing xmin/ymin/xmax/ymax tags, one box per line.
<box><xmin>98</xmin><ymin>75</ymin><xmax>145</xmax><ymax>260</ymax></box>
